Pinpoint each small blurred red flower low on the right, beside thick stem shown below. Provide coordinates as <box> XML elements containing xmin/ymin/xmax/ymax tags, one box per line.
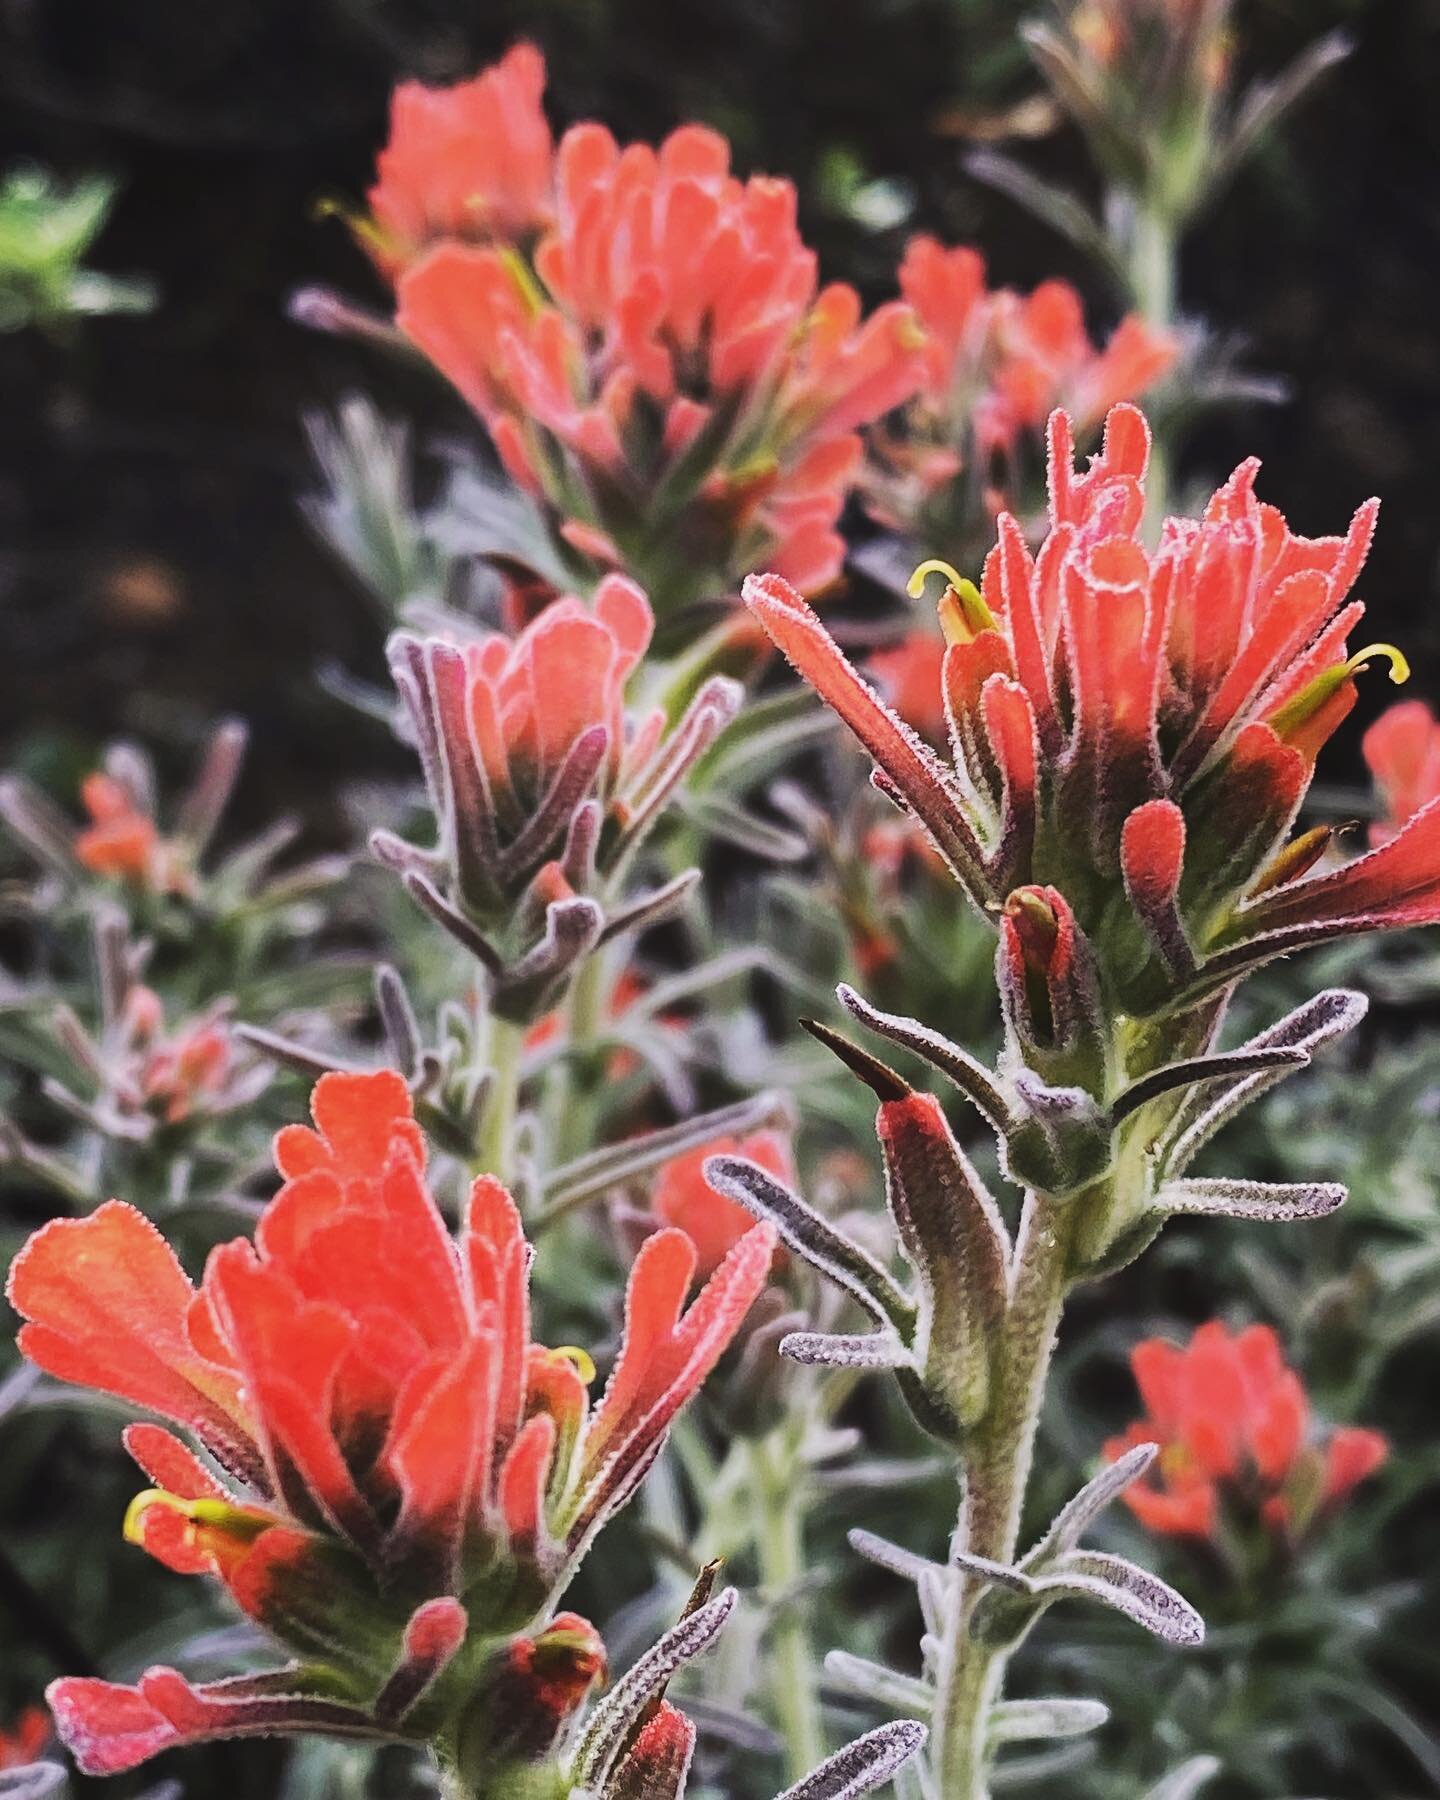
<box><xmin>1105</xmin><ymin>1321</ymin><xmax>1386</xmax><ymax>1537</ymax></box>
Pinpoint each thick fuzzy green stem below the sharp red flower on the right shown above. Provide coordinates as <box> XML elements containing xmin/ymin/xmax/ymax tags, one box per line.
<box><xmin>931</xmin><ymin>1195</ymin><xmax>1071</xmax><ymax>1800</ymax></box>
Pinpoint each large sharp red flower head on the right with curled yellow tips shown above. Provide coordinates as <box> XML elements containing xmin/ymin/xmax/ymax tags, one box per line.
<box><xmin>745</xmin><ymin>405</ymin><xmax>1440</xmax><ymax>1013</ymax></box>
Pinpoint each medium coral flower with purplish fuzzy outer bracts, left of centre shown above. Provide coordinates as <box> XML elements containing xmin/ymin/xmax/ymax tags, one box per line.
<box><xmin>373</xmin><ymin>576</ymin><xmax>740</xmax><ymax>1024</ymax></box>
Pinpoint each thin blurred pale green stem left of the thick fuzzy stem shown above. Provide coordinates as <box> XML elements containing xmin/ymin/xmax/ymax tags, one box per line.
<box><xmin>752</xmin><ymin>1433</ymin><xmax>824</xmax><ymax>1782</ymax></box>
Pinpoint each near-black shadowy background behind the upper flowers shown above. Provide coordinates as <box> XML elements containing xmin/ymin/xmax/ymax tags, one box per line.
<box><xmin>0</xmin><ymin>0</ymin><xmax>1440</xmax><ymax>805</ymax></box>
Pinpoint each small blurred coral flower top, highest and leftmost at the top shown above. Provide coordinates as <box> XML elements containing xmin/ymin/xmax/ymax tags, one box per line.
<box><xmin>356</xmin><ymin>43</ymin><xmax>554</xmax><ymax>279</ymax></box>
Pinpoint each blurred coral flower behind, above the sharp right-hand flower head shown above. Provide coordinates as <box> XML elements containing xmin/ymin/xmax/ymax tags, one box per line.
<box><xmin>860</xmin><ymin>238</ymin><xmax>1175</xmax><ymax>547</ymax></box>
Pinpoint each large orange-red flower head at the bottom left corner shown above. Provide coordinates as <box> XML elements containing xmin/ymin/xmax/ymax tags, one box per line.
<box><xmin>9</xmin><ymin>1071</ymin><xmax>774</xmax><ymax>1768</ymax></box>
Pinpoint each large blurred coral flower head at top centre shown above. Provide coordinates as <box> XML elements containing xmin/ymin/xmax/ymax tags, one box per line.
<box><xmin>385</xmin><ymin>51</ymin><xmax>920</xmax><ymax>619</ymax></box>
